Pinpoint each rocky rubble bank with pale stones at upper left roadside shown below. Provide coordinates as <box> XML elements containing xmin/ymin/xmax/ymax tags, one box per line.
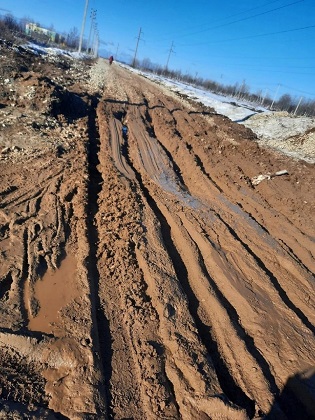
<box><xmin>0</xmin><ymin>41</ymin><xmax>96</xmax><ymax>161</ymax></box>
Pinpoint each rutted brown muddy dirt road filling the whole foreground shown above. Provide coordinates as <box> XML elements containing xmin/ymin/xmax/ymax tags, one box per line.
<box><xmin>0</xmin><ymin>44</ymin><xmax>315</xmax><ymax>420</ymax></box>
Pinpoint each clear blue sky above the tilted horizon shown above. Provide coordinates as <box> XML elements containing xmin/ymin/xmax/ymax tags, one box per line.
<box><xmin>0</xmin><ymin>0</ymin><xmax>315</xmax><ymax>99</ymax></box>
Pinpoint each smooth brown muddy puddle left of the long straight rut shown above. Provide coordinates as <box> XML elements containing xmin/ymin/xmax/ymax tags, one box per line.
<box><xmin>25</xmin><ymin>255</ymin><xmax>78</xmax><ymax>334</ymax></box>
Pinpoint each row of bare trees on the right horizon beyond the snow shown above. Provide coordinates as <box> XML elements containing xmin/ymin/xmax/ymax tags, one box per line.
<box><xmin>135</xmin><ymin>58</ymin><xmax>315</xmax><ymax>116</ymax></box>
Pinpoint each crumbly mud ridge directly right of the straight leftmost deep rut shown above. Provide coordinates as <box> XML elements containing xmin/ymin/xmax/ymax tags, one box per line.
<box><xmin>98</xmin><ymin>102</ymin><xmax>183</xmax><ymax>419</ymax></box>
